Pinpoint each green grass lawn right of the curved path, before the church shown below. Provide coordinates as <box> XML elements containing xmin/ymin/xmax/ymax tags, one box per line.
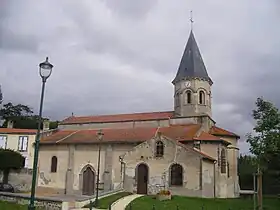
<box><xmin>126</xmin><ymin>196</ymin><xmax>280</xmax><ymax>210</ymax></box>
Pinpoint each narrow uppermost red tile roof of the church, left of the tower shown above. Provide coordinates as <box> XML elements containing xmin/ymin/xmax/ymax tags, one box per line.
<box><xmin>60</xmin><ymin>111</ymin><xmax>173</xmax><ymax>125</ymax></box>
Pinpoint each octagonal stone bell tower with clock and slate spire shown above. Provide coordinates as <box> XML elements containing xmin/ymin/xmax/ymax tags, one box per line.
<box><xmin>172</xmin><ymin>30</ymin><xmax>213</xmax><ymax>117</ymax></box>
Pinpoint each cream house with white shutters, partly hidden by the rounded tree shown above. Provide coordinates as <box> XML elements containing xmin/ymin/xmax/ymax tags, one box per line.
<box><xmin>0</xmin><ymin>121</ymin><xmax>52</xmax><ymax>169</ymax></box>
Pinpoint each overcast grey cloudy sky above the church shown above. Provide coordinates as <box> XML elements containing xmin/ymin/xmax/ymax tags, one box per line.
<box><xmin>0</xmin><ymin>0</ymin><xmax>280</xmax><ymax>153</ymax></box>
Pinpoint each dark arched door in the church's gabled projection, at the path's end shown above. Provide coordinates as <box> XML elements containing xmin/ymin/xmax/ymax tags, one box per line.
<box><xmin>137</xmin><ymin>163</ymin><xmax>149</xmax><ymax>194</ymax></box>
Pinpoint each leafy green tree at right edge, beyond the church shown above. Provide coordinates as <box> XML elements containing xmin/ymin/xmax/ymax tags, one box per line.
<box><xmin>247</xmin><ymin>98</ymin><xmax>280</xmax><ymax>169</ymax></box>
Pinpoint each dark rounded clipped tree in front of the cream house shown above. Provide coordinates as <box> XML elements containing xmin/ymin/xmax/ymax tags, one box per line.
<box><xmin>0</xmin><ymin>148</ymin><xmax>25</xmax><ymax>184</ymax></box>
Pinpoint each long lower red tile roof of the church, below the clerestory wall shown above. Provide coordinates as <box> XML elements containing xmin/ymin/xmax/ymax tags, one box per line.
<box><xmin>41</xmin><ymin>124</ymin><xmax>200</xmax><ymax>143</ymax></box>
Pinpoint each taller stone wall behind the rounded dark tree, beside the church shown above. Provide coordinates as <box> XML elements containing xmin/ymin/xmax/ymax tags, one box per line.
<box><xmin>0</xmin><ymin>168</ymin><xmax>32</xmax><ymax>192</ymax></box>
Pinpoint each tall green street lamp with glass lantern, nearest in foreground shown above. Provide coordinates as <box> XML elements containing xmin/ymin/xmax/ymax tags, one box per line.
<box><xmin>28</xmin><ymin>57</ymin><xmax>53</xmax><ymax>210</ymax></box>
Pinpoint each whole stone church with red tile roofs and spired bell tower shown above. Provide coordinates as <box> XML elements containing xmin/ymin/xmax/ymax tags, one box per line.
<box><xmin>38</xmin><ymin>31</ymin><xmax>239</xmax><ymax>198</ymax></box>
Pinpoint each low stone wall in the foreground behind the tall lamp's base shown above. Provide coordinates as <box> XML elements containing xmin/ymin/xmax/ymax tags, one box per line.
<box><xmin>0</xmin><ymin>192</ymin><xmax>63</xmax><ymax>210</ymax></box>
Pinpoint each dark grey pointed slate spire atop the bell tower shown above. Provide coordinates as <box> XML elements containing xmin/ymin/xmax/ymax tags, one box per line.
<box><xmin>172</xmin><ymin>30</ymin><xmax>213</xmax><ymax>85</ymax></box>
